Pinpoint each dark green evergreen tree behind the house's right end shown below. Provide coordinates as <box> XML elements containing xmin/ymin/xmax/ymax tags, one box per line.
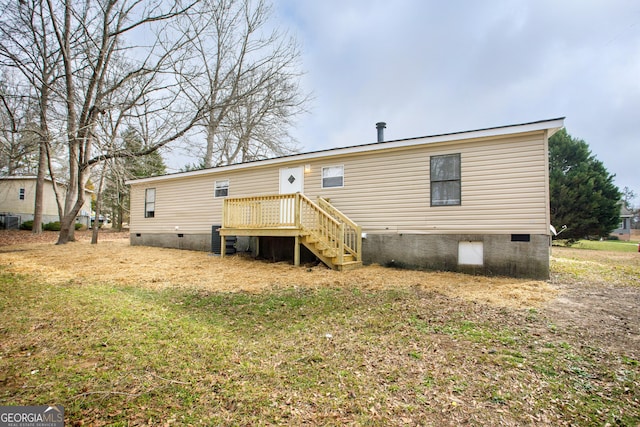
<box><xmin>549</xmin><ymin>129</ymin><xmax>621</xmax><ymax>242</ymax></box>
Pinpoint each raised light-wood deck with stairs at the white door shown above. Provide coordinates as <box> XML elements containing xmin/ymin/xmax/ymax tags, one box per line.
<box><xmin>220</xmin><ymin>193</ymin><xmax>362</xmax><ymax>270</ymax></box>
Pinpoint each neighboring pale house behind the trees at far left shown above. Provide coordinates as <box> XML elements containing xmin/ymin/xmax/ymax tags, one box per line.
<box><xmin>0</xmin><ymin>176</ymin><xmax>91</xmax><ymax>228</ymax></box>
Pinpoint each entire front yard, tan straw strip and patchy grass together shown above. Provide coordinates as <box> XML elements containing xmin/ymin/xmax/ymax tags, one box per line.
<box><xmin>0</xmin><ymin>235</ymin><xmax>640</xmax><ymax>426</ymax></box>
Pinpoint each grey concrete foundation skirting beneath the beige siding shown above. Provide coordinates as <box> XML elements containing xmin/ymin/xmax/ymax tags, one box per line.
<box><xmin>130</xmin><ymin>233</ymin><xmax>549</xmax><ymax>280</ymax></box>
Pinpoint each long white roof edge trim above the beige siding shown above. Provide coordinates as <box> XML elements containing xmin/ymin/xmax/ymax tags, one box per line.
<box><xmin>126</xmin><ymin>117</ymin><xmax>564</xmax><ymax>184</ymax></box>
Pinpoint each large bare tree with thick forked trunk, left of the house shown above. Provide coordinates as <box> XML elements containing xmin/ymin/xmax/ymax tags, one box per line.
<box><xmin>2</xmin><ymin>0</ymin><xmax>208</xmax><ymax>244</ymax></box>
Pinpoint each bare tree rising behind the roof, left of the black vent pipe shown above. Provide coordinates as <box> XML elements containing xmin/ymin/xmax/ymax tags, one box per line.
<box><xmin>181</xmin><ymin>0</ymin><xmax>308</xmax><ymax>167</ymax></box>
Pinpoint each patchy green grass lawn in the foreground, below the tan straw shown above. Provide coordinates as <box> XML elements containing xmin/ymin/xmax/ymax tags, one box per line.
<box><xmin>0</xmin><ymin>267</ymin><xmax>640</xmax><ymax>426</ymax></box>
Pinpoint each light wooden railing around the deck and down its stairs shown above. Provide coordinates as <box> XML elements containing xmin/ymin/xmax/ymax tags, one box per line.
<box><xmin>222</xmin><ymin>193</ymin><xmax>362</xmax><ymax>263</ymax></box>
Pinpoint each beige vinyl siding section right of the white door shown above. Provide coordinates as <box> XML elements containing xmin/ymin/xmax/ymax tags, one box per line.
<box><xmin>305</xmin><ymin>132</ymin><xmax>548</xmax><ymax>234</ymax></box>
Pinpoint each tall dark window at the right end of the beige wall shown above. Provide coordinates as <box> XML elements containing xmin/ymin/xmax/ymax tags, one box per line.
<box><xmin>431</xmin><ymin>154</ymin><xmax>461</xmax><ymax>206</ymax></box>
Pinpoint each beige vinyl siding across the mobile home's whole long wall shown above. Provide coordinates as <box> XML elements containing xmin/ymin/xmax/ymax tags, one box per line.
<box><xmin>131</xmin><ymin>131</ymin><xmax>549</xmax><ymax>234</ymax></box>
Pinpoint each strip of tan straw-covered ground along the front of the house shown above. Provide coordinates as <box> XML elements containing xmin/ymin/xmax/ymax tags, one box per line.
<box><xmin>2</xmin><ymin>238</ymin><xmax>557</xmax><ymax>308</ymax></box>
